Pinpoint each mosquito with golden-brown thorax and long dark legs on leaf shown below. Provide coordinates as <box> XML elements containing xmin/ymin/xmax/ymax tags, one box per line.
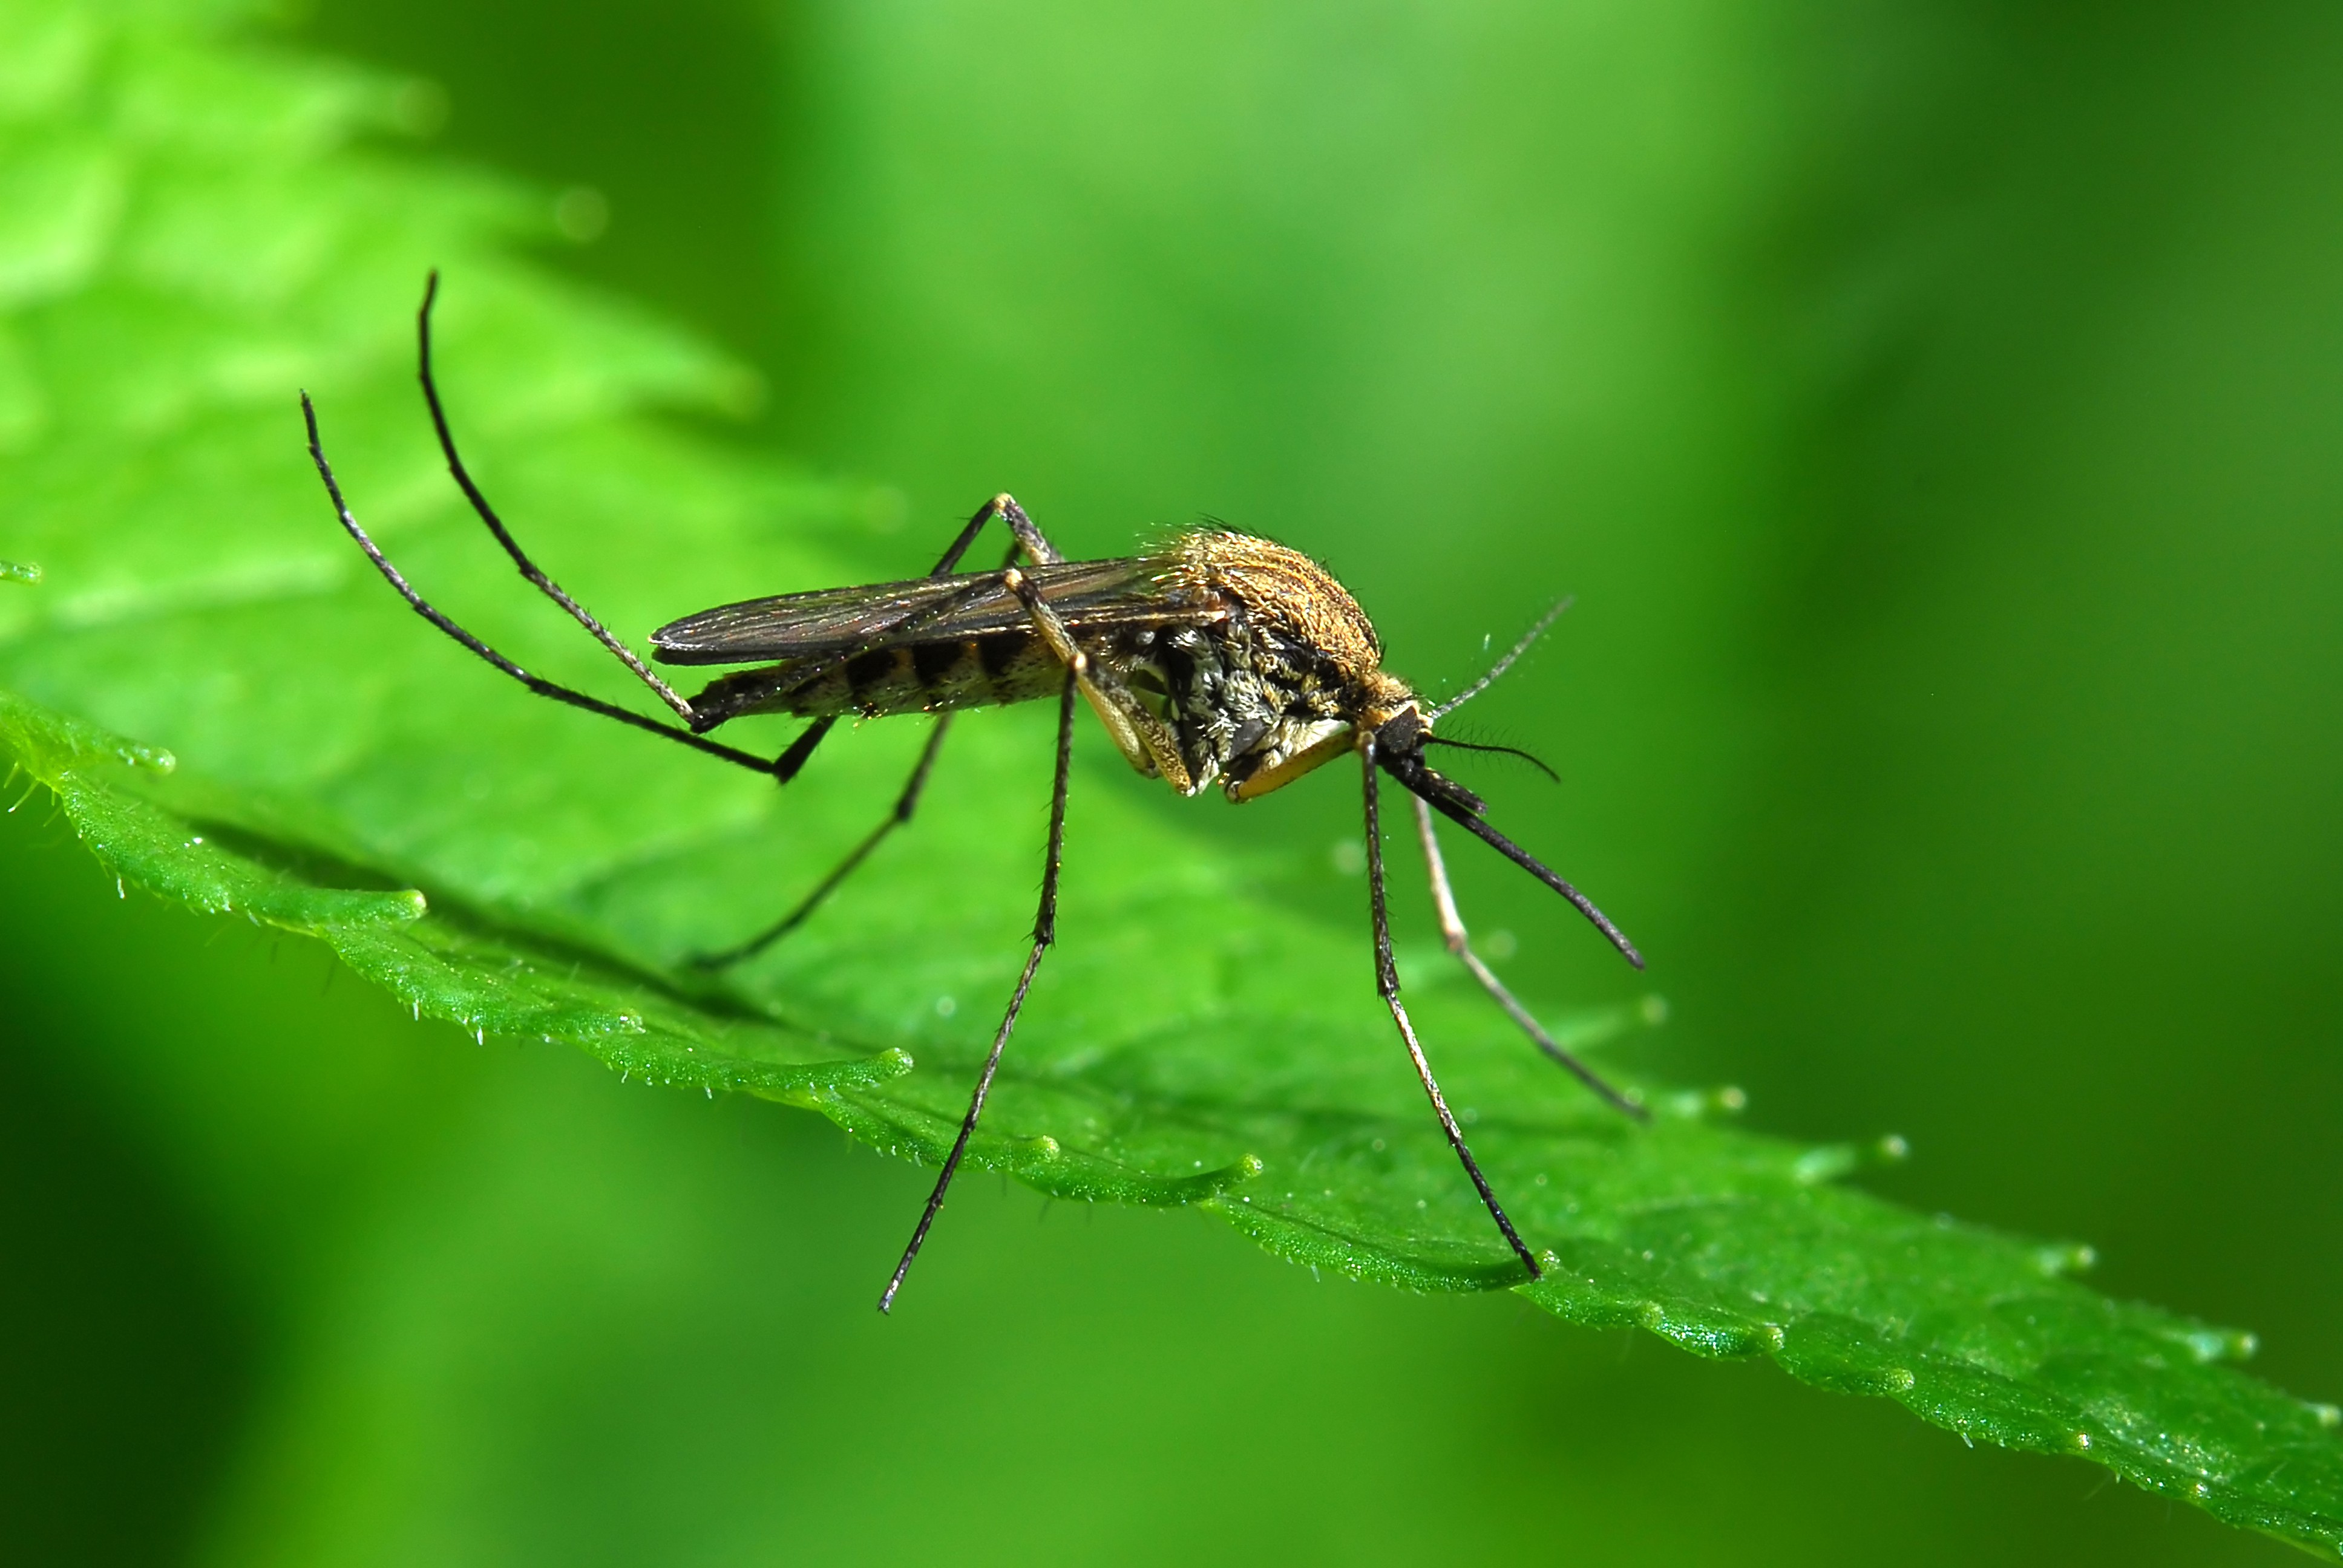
<box><xmin>300</xmin><ymin>272</ymin><xmax>1647</xmax><ymax>1313</ymax></box>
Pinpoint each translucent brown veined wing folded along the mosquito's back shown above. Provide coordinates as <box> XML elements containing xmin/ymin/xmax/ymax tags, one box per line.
<box><xmin>651</xmin><ymin>555</ymin><xmax>1199</xmax><ymax>663</ymax></box>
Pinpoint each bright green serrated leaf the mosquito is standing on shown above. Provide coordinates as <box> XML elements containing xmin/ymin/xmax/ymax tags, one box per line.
<box><xmin>0</xmin><ymin>5</ymin><xmax>2343</xmax><ymax>1549</ymax></box>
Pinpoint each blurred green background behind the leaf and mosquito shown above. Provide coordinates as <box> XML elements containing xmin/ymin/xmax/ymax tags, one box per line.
<box><xmin>0</xmin><ymin>0</ymin><xmax>2343</xmax><ymax>1563</ymax></box>
